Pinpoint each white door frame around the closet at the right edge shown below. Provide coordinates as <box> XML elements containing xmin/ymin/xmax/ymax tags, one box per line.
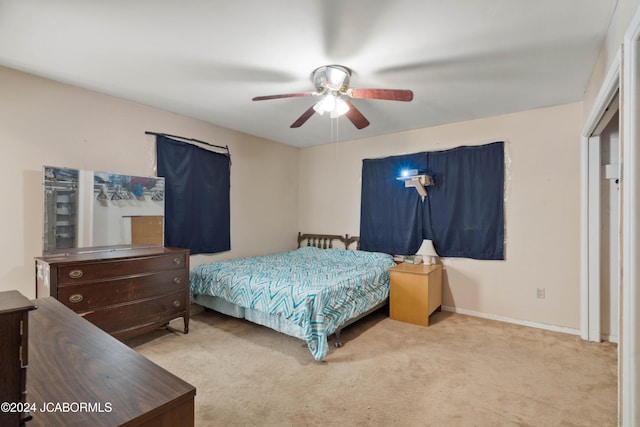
<box><xmin>580</xmin><ymin>8</ymin><xmax>640</xmax><ymax>427</ymax></box>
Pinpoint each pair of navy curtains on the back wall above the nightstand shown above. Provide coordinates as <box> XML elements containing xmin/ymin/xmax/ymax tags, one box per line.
<box><xmin>360</xmin><ymin>142</ymin><xmax>504</xmax><ymax>260</ymax></box>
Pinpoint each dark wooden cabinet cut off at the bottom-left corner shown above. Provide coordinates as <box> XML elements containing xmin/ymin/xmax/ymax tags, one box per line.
<box><xmin>0</xmin><ymin>291</ymin><xmax>36</xmax><ymax>427</ymax></box>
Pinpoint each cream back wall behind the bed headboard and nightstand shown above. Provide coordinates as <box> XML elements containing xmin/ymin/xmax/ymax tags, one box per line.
<box><xmin>299</xmin><ymin>103</ymin><xmax>582</xmax><ymax>330</ymax></box>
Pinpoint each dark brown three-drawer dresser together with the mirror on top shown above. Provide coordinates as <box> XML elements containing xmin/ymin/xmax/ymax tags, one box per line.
<box><xmin>35</xmin><ymin>166</ymin><xmax>190</xmax><ymax>339</ymax></box>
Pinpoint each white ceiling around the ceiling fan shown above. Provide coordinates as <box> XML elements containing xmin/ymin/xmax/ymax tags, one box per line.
<box><xmin>0</xmin><ymin>0</ymin><xmax>616</xmax><ymax>147</ymax></box>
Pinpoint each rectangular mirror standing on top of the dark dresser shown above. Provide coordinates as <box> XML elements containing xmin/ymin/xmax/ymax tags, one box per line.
<box><xmin>42</xmin><ymin>166</ymin><xmax>165</xmax><ymax>255</ymax></box>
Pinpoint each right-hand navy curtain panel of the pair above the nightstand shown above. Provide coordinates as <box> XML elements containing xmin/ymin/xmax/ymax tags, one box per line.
<box><xmin>423</xmin><ymin>142</ymin><xmax>504</xmax><ymax>260</ymax></box>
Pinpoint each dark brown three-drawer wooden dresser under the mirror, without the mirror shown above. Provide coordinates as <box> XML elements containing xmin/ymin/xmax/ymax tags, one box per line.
<box><xmin>36</xmin><ymin>246</ymin><xmax>190</xmax><ymax>339</ymax></box>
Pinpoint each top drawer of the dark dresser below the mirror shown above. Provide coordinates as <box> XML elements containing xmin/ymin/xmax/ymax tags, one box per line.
<box><xmin>57</xmin><ymin>253</ymin><xmax>186</xmax><ymax>285</ymax></box>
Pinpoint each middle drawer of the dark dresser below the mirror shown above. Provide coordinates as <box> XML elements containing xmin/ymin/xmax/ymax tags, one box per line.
<box><xmin>58</xmin><ymin>269</ymin><xmax>189</xmax><ymax>312</ymax></box>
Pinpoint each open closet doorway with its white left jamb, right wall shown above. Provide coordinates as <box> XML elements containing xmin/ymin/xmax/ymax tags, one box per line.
<box><xmin>581</xmin><ymin>87</ymin><xmax>622</xmax><ymax>343</ymax></box>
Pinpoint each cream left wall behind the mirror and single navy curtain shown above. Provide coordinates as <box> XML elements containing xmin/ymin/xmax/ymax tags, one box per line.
<box><xmin>0</xmin><ymin>67</ymin><xmax>298</xmax><ymax>298</ymax></box>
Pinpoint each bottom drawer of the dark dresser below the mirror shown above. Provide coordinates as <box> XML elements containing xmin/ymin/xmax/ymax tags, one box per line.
<box><xmin>81</xmin><ymin>292</ymin><xmax>188</xmax><ymax>337</ymax></box>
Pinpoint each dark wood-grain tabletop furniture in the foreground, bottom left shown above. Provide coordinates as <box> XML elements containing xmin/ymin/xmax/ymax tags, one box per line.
<box><xmin>26</xmin><ymin>297</ymin><xmax>196</xmax><ymax>427</ymax></box>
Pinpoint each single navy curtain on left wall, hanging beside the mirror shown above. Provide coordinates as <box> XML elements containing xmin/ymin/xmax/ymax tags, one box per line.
<box><xmin>156</xmin><ymin>135</ymin><xmax>231</xmax><ymax>255</ymax></box>
